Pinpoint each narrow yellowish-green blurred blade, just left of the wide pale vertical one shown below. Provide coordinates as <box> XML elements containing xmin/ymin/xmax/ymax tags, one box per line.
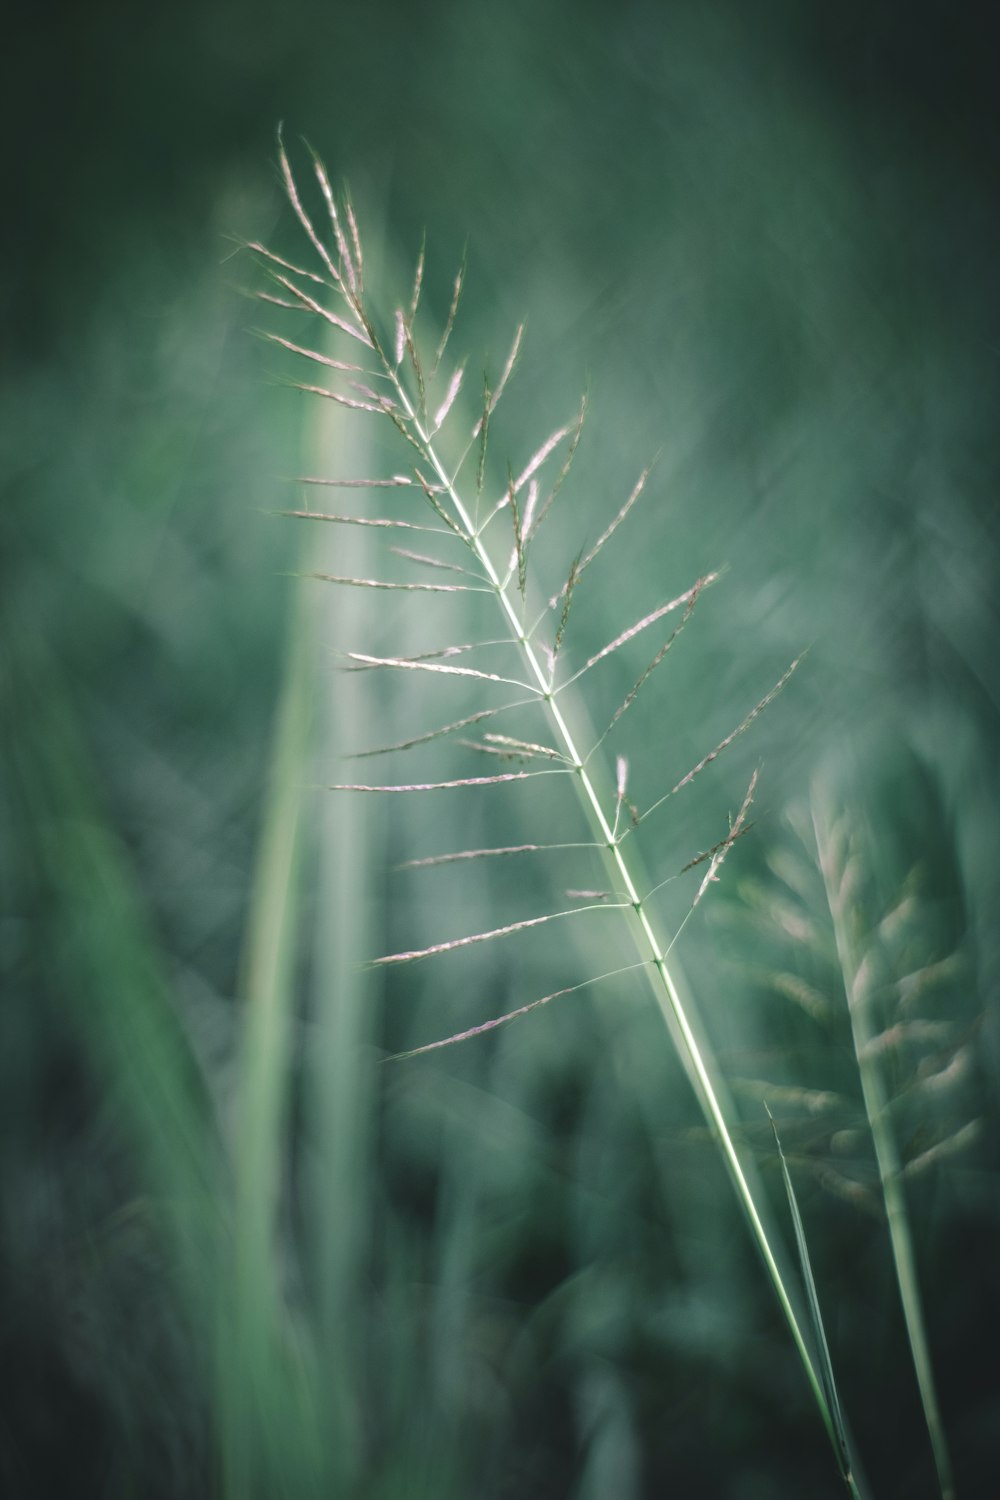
<box><xmin>220</xmin><ymin>552</ymin><xmax>322</xmax><ymax>1500</ymax></box>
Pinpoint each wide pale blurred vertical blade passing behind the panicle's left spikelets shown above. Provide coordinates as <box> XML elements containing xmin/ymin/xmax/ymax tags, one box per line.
<box><xmin>303</xmin><ymin>369</ymin><xmax>381</xmax><ymax>1496</ymax></box>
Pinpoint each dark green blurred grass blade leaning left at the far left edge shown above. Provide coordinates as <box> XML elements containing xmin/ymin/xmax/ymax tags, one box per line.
<box><xmin>0</xmin><ymin>618</ymin><xmax>223</xmax><ymax>1296</ymax></box>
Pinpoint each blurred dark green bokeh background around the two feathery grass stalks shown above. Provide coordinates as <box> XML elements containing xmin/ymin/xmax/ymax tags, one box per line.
<box><xmin>0</xmin><ymin>0</ymin><xmax>1000</xmax><ymax>1500</ymax></box>
